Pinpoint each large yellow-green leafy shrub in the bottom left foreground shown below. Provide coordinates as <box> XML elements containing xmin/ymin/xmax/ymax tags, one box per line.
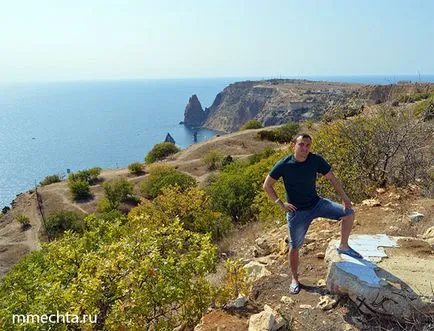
<box><xmin>0</xmin><ymin>211</ymin><xmax>217</xmax><ymax>330</ymax></box>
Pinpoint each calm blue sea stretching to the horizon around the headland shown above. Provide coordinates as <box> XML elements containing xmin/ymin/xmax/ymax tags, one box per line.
<box><xmin>0</xmin><ymin>75</ymin><xmax>434</xmax><ymax>209</ymax></box>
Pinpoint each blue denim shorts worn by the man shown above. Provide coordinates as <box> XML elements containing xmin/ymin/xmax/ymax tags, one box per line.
<box><xmin>286</xmin><ymin>198</ymin><xmax>354</xmax><ymax>248</ymax></box>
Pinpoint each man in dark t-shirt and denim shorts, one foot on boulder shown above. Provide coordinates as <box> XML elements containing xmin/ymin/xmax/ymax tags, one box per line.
<box><xmin>263</xmin><ymin>134</ymin><xmax>362</xmax><ymax>294</ymax></box>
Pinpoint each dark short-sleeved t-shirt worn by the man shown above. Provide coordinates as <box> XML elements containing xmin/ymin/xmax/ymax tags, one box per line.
<box><xmin>269</xmin><ymin>153</ymin><xmax>331</xmax><ymax>210</ymax></box>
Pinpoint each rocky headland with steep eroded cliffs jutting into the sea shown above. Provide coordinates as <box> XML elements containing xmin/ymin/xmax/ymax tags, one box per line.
<box><xmin>186</xmin><ymin>79</ymin><xmax>434</xmax><ymax>132</ymax></box>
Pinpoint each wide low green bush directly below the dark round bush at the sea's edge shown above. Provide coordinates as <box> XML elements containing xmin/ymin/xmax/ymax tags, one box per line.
<box><xmin>140</xmin><ymin>165</ymin><xmax>196</xmax><ymax>199</ymax></box>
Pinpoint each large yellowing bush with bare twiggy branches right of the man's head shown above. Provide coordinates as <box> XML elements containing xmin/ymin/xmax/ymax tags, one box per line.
<box><xmin>313</xmin><ymin>108</ymin><xmax>429</xmax><ymax>202</ymax></box>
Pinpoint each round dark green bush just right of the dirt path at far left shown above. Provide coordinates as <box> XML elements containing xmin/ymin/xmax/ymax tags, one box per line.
<box><xmin>46</xmin><ymin>210</ymin><xmax>84</xmax><ymax>238</ymax></box>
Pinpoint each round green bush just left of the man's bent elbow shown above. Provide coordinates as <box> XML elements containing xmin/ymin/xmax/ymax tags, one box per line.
<box><xmin>209</xmin><ymin>172</ymin><xmax>256</xmax><ymax>222</ymax></box>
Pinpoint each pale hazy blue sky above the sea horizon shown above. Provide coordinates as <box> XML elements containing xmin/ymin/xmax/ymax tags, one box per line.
<box><xmin>0</xmin><ymin>0</ymin><xmax>434</xmax><ymax>82</ymax></box>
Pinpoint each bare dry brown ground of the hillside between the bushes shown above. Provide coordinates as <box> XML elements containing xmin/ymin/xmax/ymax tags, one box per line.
<box><xmin>0</xmin><ymin>106</ymin><xmax>434</xmax><ymax>331</ymax></box>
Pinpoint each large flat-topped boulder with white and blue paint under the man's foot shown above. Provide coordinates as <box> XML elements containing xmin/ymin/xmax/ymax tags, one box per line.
<box><xmin>325</xmin><ymin>234</ymin><xmax>434</xmax><ymax>320</ymax></box>
